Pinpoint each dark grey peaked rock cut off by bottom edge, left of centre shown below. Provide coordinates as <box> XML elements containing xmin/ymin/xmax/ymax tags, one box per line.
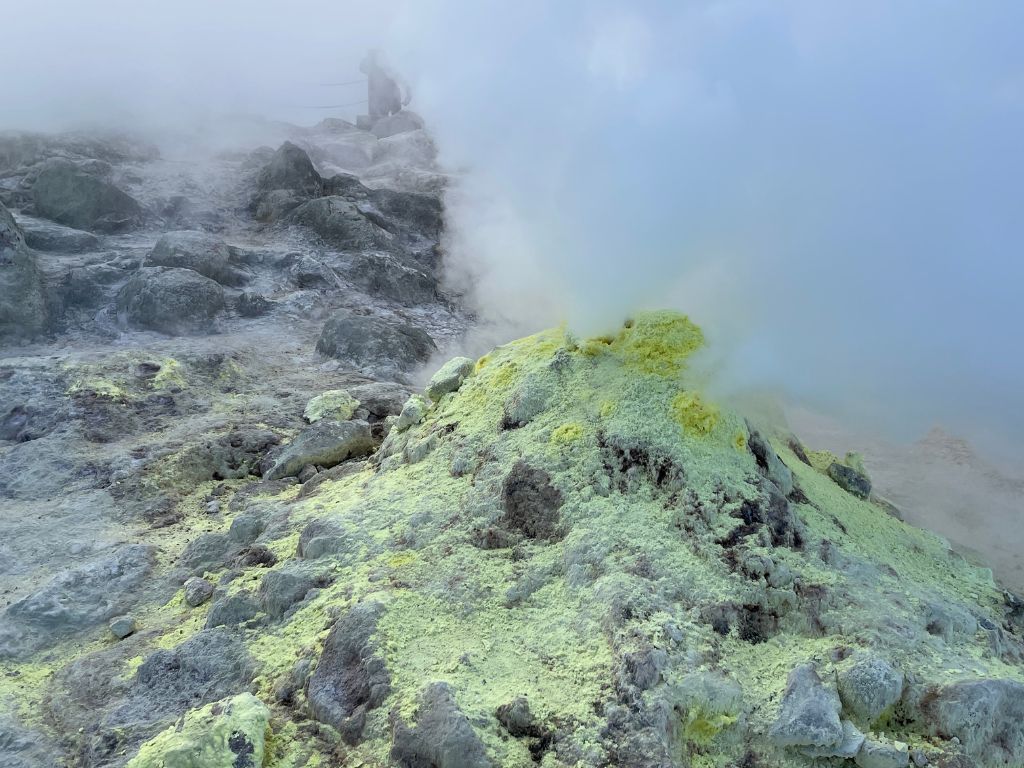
<box><xmin>391</xmin><ymin>683</ymin><xmax>494</xmax><ymax>768</ymax></box>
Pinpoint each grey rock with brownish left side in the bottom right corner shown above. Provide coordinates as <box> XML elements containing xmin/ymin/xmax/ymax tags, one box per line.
<box><xmin>920</xmin><ymin>680</ymin><xmax>1024</xmax><ymax>765</ymax></box>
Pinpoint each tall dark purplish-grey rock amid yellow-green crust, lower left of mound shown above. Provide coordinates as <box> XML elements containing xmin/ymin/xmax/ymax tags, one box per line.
<box><xmin>306</xmin><ymin>603</ymin><xmax>389</xmax><ymax>745</ymax></box>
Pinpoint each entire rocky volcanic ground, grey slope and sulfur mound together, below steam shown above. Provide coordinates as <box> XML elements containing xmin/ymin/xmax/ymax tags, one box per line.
<box><xmin>0</xmin><ymin>119</ymin><xmax>1024</xmax><ymax>768</ymax></box>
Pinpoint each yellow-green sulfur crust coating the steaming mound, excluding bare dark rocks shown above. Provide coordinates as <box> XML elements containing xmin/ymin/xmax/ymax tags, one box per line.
<box><xmin>6</xmin><ymin>312</ymin><xmax>1024</xmax><ymax>768</ymax></box>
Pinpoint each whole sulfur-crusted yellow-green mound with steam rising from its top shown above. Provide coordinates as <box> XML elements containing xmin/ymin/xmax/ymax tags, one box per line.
<box><xmin>0</xmin><ymin>312</ymin><xmax>1024</xmax><ymax>768</ymax></box>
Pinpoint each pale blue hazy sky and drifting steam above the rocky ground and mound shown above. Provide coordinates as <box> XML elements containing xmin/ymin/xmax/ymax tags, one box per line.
<box><xmin>0</xmin><ymin>0</ymin><xmax>1024</xmax><ymax>456</ymax></box>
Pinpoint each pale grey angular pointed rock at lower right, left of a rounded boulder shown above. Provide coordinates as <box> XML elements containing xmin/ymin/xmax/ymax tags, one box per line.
<box><xmin>768</xmin><ymin>664</ymin><xmax>843</xmax><ymax>746</ymax></box>
